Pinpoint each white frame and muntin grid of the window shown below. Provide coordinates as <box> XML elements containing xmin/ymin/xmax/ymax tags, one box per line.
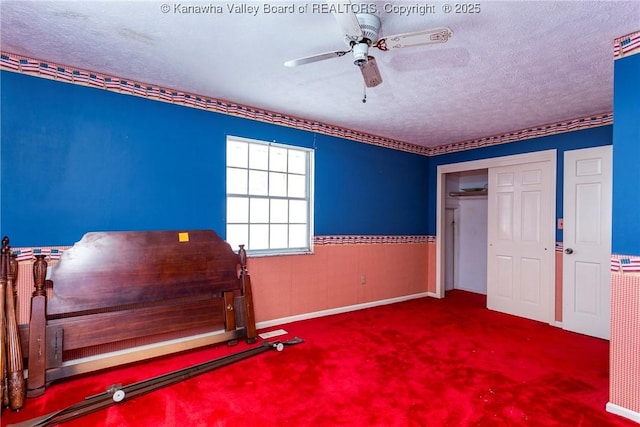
<box><xmin>225</xmin><ymin>135</ymin><xmax>314</xmax><ymax>256</ymax></box>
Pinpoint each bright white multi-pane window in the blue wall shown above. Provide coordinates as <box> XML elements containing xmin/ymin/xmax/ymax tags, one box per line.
<box><xmin>227</xmin><ymin>136</ymin><xmax>313</xmax><ymax>255</ymax></box>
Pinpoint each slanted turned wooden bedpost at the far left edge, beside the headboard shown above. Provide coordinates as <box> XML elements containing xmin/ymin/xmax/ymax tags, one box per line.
<box><xmin>2</xmin><ymin>237</ymin><xmax>26</xmax><ymax>410</ymax></box>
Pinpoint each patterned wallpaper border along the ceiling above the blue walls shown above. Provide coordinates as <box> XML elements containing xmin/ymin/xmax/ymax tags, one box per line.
<box><xmin>0</xmin><ymin>52</ymin><xmax>608</xmax><ymax>156</ymax></box>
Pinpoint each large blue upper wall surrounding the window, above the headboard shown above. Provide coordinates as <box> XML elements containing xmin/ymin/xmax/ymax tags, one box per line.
<box><xmin>0</xmin><ymin>71</ymin><xmax>429</xmax><ymax>246</ymax></box>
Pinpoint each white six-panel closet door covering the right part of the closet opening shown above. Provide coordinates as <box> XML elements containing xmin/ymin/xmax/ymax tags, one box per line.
<box><xmin>487</xmin><ymin>162</ymin><xmax>555</xmax><ymax>322</ymax></box>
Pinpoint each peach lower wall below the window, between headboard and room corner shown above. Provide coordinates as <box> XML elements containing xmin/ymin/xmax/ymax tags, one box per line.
<box><xmin>248</xmin><ymin>241</ymin><xmax>435</xmax><ymax>323</ymax></box>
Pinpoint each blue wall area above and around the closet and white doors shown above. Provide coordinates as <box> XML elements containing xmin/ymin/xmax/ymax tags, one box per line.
<box><xmin>428</xmin><ymin>125</ymin><xmax>612</xmax><ymax>242</ymax></box>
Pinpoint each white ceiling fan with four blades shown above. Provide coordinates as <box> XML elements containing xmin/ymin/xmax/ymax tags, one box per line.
<box><xmin>284</xmin><ymin>0</ymin><xmax>453</xmax><ymax>89</ymax></box>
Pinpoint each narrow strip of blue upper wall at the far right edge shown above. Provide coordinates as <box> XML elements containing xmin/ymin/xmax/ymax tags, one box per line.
<box><xmin>611</xmin><ymin>54</ymin><xmax>640</xmax><ymax>256</ymax></box>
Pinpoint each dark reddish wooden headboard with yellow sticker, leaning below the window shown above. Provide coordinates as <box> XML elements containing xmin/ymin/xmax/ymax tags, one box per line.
<box><xmin>22</xmin><ymin>230</ymin><xmax>256</xmax><ymax>397</ymax></box>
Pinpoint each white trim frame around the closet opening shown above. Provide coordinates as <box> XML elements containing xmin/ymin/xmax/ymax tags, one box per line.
<box><xmin>430</xmin><ymin>149</ymin><xmax>558</xmax><ymax>324</ymax></box>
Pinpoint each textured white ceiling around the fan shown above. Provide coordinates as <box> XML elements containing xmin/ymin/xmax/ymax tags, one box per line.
<box><xmin>0</xmin><ymin>0</ymin><xmax>640</xmax><ymax>146</ymax></box>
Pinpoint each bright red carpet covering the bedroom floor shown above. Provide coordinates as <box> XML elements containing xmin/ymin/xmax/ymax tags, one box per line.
<box><xmin>2</xmin><ymin>291</ymin><xmax>638</xmax><ymax>427</ymax></box>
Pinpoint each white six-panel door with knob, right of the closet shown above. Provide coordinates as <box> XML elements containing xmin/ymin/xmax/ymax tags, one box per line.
<box><xmin>562</xmin><ymin>146</ymin><xmax>612</xmax><ymax>339</ymax></box>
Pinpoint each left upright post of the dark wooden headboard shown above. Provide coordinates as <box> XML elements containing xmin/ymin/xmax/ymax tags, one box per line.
<box><xmin>27</xmin><ymin>255</ymin><xmax>47</xmax><ymax>397</ymax></box>
